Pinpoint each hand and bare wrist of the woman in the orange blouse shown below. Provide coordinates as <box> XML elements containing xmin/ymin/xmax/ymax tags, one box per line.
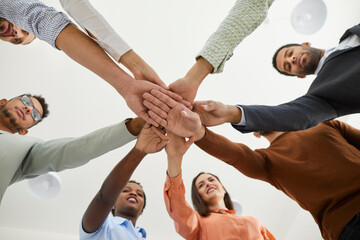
<box><xmin>165</xmin><ymin>132</ymin><xmax>195</xmax><ymax>177</ymax></box>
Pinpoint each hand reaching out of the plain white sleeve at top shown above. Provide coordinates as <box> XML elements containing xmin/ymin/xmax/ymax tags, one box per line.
<box><xmin>119</xmin><ymin>50</ymin><xmax>169</xmax><ymax>89</ymax></box>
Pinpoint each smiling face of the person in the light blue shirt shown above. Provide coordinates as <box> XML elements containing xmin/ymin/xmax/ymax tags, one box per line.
<box><xmin>115</xmin><ymin>183</ymin><xmax>144</xmax><ymax>216</ymax></box>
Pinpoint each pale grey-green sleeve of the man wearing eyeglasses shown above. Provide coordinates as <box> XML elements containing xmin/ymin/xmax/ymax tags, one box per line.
<box><xmin>17</xmin><ymin>121</ymin><xmax>136</xmax><ymax>180</ymax></box>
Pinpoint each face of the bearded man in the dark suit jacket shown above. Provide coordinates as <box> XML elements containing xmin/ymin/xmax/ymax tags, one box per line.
<box><xmin>276</xmin><ymin>43</ymin><xmax>322</xmax><ymax>77</ymax></box>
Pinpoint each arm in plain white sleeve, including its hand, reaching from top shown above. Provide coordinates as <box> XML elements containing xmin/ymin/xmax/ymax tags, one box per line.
<box><xmin>59</xmin><ymin>0</ymin><xmax>167</xmax><ymax>88</ymax></box>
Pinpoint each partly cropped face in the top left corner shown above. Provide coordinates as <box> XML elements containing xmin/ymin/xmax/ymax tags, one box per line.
<box><xmin>0</xmin><ymin>18</ymin><xmax>35</xmax><ymax>44</ymax></box>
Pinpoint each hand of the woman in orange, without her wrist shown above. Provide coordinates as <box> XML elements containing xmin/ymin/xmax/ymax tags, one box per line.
<box><xmin>165</xmin><ymin>132</ymin><xmax>195</xmax><ymax>159</ymax></box>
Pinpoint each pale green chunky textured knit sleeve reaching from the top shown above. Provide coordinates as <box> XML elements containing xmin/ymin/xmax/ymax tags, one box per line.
<box><xmin>196</xmin><ymin>0</ymin><xmax>274</xmax><ymax>73</ymax></box>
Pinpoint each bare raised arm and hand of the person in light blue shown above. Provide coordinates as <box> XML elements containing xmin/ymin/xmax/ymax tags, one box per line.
<box><xmin>82</xmin><ymin>124</ymin><xmax>167</xmax><ymax>233</ymax></box>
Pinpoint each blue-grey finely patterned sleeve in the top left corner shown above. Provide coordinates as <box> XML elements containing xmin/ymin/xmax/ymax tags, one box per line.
<box><xmin>0</xmin><ymin>0</ymin><xmax>71</xmax><ymax>48</ymax></box>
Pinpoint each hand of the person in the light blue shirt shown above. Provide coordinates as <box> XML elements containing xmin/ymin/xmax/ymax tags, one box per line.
<box><xmin>135</xmin><ymin>123</ymin><xmax>169</xmax><ymax>153</ymax></box>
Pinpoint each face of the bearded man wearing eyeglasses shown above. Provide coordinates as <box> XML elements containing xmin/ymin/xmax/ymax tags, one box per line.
<box><xmin>0</xmin><ymin>97</ymin><xmax>43</xmax><ymax>134</ymax></box>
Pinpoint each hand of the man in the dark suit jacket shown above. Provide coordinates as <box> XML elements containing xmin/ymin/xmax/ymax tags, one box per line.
<box><xmin>194</xmin><ymin>100</ymin><xmax>241</xmax><ymax>126</ymax></box>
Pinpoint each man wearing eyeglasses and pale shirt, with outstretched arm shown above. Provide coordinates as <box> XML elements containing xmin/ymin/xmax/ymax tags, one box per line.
<box><xmin>0</xmin><ymin>94</ymin><xmax>144</xmax><ymax>203</ymax></box>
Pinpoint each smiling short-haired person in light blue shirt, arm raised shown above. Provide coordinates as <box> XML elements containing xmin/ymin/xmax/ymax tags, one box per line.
<box><xmin>80</xmin><ymin>124</ymin><xmax>168</xmax><ymax>240</ymax></box>
